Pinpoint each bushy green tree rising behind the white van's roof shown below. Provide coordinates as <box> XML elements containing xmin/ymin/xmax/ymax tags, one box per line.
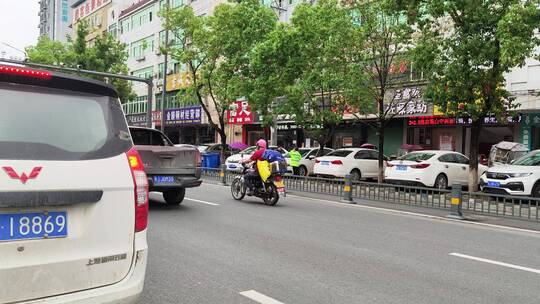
<box><xmin>26</xmin><ymin>22</ymin><xmax>135</xmax><ymax>103</ymax></box>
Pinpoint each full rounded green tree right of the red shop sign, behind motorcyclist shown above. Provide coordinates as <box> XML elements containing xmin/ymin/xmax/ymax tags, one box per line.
<box><xmin>251</xmin><ymin>0</ymin><xmax>356</xmax><ymax>157</ymax></box>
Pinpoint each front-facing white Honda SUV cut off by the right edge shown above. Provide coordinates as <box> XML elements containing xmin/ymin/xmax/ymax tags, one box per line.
<box><xmin>480</xmin><ymin>150</ymin><xmax>540</xmax><ymax>197</ymax></box>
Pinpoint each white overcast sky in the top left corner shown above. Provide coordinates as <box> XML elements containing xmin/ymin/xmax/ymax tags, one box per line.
<box><xmin>0</xmin><ymin>0</ymin><xmax>39</xmax><ymax>56</ymax></box>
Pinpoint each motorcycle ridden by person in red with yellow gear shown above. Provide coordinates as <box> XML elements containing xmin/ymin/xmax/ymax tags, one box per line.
<box><xmin>231</xmin><ymin>165</ymin><xmax>285</xmax><ymax>206</ymax></box>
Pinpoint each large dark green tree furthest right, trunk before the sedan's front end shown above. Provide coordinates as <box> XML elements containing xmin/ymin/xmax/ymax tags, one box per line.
<box><xmin>408</xmin><ymin>0</ymin><xmax>540</xmax><ymax>190</ymax></box>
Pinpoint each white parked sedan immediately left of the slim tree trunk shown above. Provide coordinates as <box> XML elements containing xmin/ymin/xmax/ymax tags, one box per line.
<box><xmin>313</xmin><ymin>148</ymin><xmax>379</xmax><ymax>180</ymax></box>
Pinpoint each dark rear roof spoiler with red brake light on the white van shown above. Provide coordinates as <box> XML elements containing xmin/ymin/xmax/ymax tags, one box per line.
<box><xmin>0</xmin><ymin>60</ymin><xmax>118</xmax><ymax>98</ymax></box>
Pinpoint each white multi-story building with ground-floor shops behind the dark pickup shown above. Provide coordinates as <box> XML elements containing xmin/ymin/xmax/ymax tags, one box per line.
<box><xmin>117</xmin><ymin>0</ymin><xmax>229</xmax><ymax>144</ymax></box>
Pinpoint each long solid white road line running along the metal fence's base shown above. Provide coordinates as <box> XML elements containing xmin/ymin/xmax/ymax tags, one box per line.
<box><xmin>199</xmin><ymin>183</ymin><xmax>540</xmax><ymax>235</ymax></box>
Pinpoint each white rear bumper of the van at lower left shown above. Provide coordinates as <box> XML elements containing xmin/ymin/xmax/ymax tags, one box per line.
<box><xmin>22</xmin><ymin>231</ymin><xmax>148</xmax><ymax>304</ymax></box>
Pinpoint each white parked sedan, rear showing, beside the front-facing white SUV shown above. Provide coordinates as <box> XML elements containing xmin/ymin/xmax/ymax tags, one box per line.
<box><xmin>385</xmin><ymin>150</ymin><xmax>487</xmax><ymax>189</ymax></box>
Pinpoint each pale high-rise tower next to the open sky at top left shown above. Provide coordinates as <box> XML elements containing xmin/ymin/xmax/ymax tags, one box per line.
<box><xmin>38</xmin><ymin>0</ymin><xmax>74</xmax><ymax>42</ymax></box>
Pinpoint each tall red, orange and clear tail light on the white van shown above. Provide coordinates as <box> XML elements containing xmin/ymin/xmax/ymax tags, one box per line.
<box><xmin>127</xmin><ymin>148</ymin><xmax>148</xmax><ymax>232</ymax></box>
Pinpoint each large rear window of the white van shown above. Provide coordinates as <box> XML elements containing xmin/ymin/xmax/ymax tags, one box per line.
<box><xmin>0</xmin><ymin>83</ymin><xmax>132</xmax><ymax>160</ymax></box>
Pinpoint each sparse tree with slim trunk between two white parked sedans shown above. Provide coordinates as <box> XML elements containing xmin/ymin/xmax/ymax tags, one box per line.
<box><xmin>346</xmin><ymin>0</ymin><xmax>420</xmax><ymax>183</ymax></box>
